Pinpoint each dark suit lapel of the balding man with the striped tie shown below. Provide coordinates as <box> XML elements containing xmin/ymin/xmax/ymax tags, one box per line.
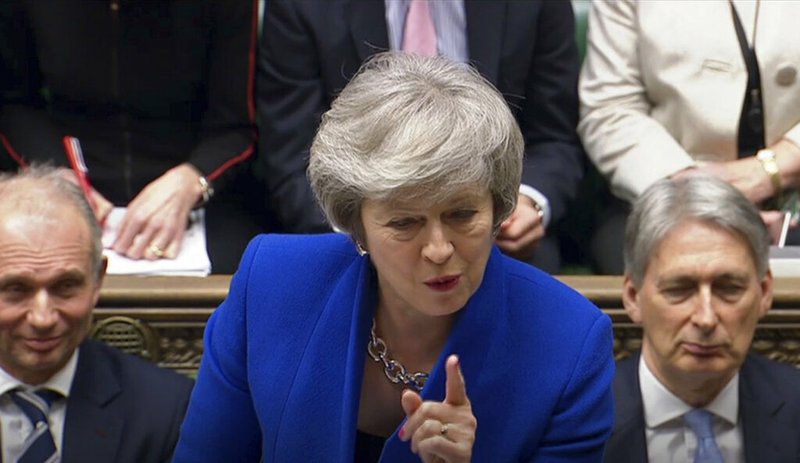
<box><xmin>62</xmin><ymin>341</ymin><xmax>124</xmax><ymax>463</ymax></box>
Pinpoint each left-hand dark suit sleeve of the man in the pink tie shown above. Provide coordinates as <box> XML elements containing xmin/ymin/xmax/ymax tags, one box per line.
<box><xmin>257</xmin><ymin>0</ymin><xmax>330</xmax><ymax>233</ymax></box>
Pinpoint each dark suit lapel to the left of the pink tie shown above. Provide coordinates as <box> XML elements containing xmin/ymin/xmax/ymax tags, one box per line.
<box><xmin>347</xmin><ymin>0</ymin><xmax>389</xmax><ymax>62</ymax></box>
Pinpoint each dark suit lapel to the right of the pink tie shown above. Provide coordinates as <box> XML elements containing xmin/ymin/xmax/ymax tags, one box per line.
<box><xmin>464</xmin><ymin>0</ymin><xmax>506</xmax><ymax>84</ymax></box>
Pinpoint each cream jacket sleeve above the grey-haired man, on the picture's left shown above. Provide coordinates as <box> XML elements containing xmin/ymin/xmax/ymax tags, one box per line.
<box><xmin>578</xmin><ymin>0</ymin><xmax>694</xmax><ymax>201</ymax></box>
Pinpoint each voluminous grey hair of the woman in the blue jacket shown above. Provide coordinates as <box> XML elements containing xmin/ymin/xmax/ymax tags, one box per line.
<box><xmin>308</xmin><ymin>52</ymin><xmax>524</xmax><ymax>240</ymax></box>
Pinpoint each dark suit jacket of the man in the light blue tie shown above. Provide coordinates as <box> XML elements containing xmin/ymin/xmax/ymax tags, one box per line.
<box><xmin>604</xmin><ymin>355</ymin><xmax>800</xmax><ymax>463</ymax></box>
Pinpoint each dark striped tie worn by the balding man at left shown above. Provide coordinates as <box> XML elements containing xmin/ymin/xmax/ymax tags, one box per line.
<box><xmin>10</xmin><ymin>389</ymin><xmax>61</xmax><ymax>463</ymax></box>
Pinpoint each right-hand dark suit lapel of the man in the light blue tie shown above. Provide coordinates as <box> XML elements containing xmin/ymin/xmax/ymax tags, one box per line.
<box><xmin>739</xmin><ymin>357</ymin><xmax>796</xmax><ymax>462</ymax></box>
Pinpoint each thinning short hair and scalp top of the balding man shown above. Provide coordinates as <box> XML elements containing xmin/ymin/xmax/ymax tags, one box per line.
<box><xmin>0</xmin><ymin>164</ymin><xmax>103</xmax><ymax>278</ymax></box>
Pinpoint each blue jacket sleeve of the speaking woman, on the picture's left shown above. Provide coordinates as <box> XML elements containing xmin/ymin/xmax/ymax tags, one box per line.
<box><xmin>172</xmin><ymin>239</ymin><xmax>261</xmax><ymax>463</ymax></box>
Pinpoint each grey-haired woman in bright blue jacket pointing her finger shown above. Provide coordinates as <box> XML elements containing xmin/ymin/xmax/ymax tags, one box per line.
<box><xmin>174</xmin><ymin>53</ymin><xmax>614</xmax><ymax>462</ymax></box>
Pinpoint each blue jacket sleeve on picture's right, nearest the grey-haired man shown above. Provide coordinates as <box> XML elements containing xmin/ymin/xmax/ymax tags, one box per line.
<box><xmin>529</xmin><ymin>315</ymin><xmax>615</xmax><ymax>463</ymax></box>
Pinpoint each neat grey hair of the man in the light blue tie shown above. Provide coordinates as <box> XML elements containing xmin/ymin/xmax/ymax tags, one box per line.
<box><xmin>625</xmin><ymin>176</ymin><xmax>771</xmax><ymax>287</ymax></box>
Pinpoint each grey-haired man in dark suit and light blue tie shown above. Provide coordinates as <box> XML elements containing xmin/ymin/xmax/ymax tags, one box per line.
<box><xmin>605</xmin><ymin>176</ymin><xmax>800</xmax><ymax>463</ymax></box>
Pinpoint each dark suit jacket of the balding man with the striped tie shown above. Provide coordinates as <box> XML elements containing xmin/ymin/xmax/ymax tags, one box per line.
<box><xmin>61</xmin><ymin>341</ymin><xmax>193</xmax><ymax>463</ymax></box>
